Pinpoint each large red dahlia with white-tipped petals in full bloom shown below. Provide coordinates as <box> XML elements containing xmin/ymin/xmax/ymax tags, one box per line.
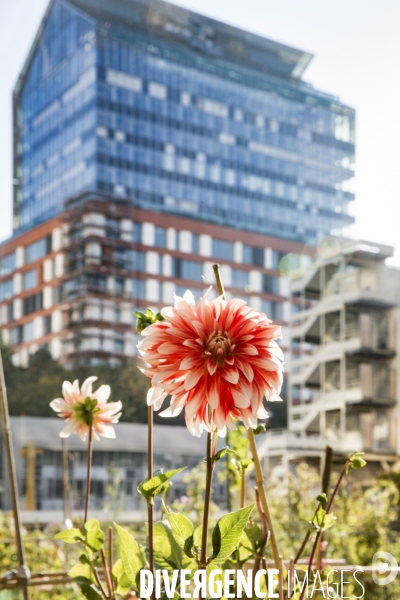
<box><xmin>138</xmin><ymin>291</ymin><xmax>283</xmax><ymax>436</ymax></box>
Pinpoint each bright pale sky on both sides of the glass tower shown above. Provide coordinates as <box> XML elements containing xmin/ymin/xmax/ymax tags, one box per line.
<box><xmin>0</xmin><ymin>0</ymin><xmax>400</xmax><ymax>266</ymax></box>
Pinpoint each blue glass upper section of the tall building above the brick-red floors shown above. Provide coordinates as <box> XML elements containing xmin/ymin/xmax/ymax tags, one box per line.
<box><xmin>15</xmin><ymin>0</ymin><xmax>354</xmax><ymax>243</ymax></box>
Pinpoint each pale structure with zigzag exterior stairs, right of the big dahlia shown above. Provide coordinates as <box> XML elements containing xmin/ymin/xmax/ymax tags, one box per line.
<box><xmin>264</xmin><ymin>240</ymin><xmax>400</xmax><ymax>474</ymax></box>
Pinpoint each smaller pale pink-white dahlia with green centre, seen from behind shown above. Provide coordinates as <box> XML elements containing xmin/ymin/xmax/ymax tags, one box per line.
<box><xmin>50</xmin><ymin>377</ymin><xmax>122</xmax><ymax>440</ymax></box>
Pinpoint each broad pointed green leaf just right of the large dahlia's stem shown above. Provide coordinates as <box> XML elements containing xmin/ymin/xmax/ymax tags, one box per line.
<box><xmin>212</xmin><ymin>504</ymin><xmax>254</xmax><ymax>562</ymax></box>
